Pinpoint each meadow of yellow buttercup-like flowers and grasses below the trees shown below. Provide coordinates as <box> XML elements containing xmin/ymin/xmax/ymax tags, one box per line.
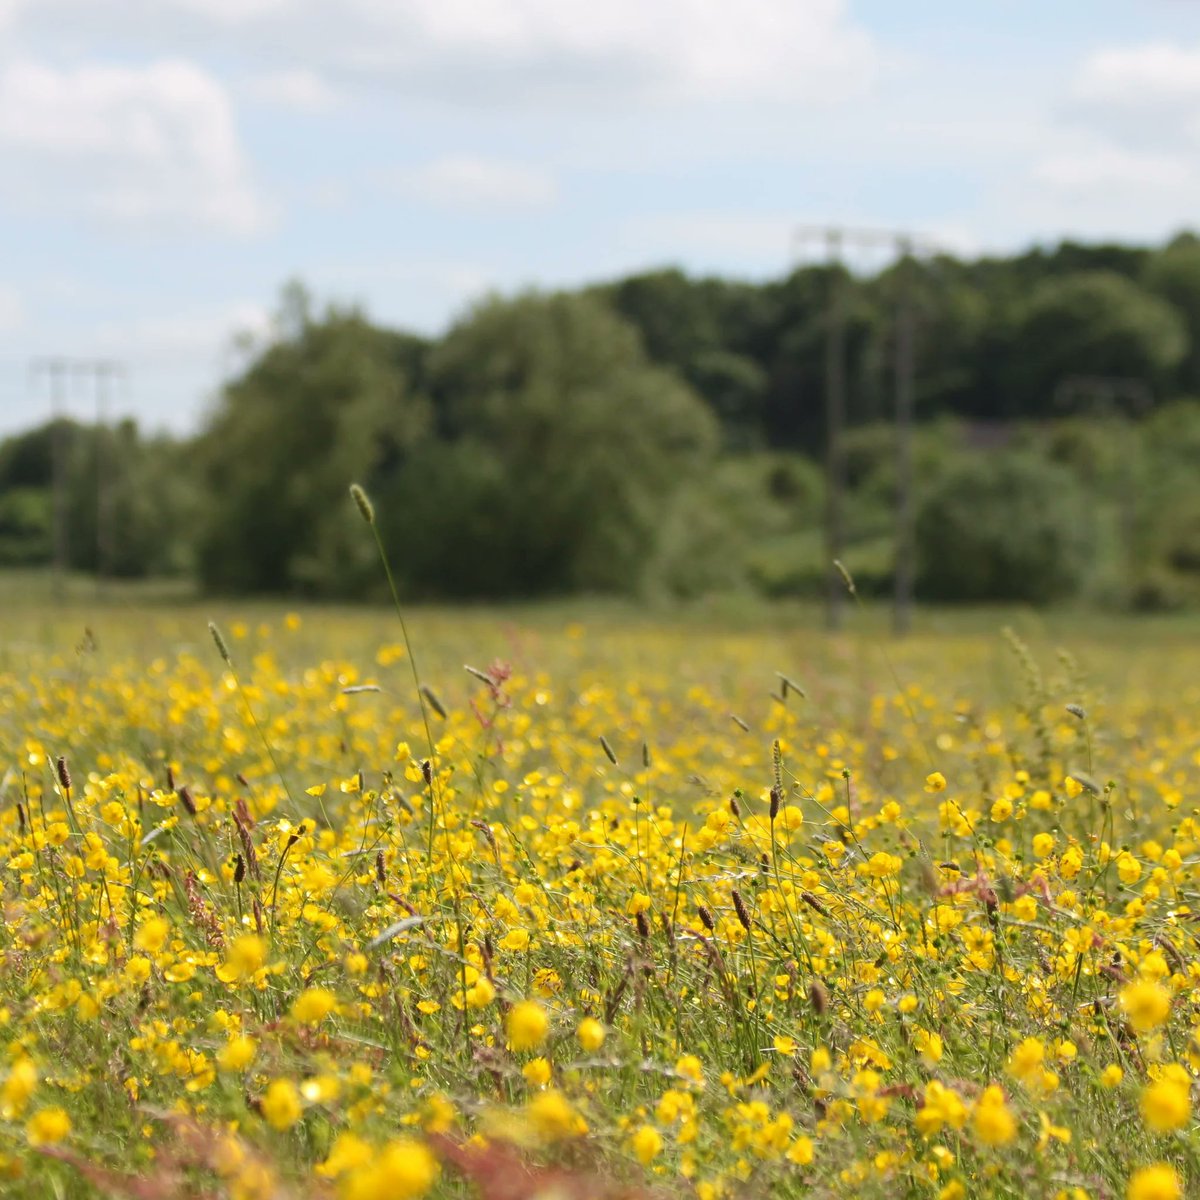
<box><xmin>0</xmin><ymin>578</ymin><xmax>1200</xmax><ymax>1200</ymax></box>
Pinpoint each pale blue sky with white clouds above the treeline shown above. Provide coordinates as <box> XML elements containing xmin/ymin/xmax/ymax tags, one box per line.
<box><xmin>0</xmin><ymin>0</ymin><xmax>1200</xmax><ymax>434</ymax></box>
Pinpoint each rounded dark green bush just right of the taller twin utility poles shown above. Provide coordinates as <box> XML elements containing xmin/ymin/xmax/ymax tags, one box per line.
<box><xmin>917</xmin><ymin>454</ymin><xmax>1094</xmax><ymax>604</ymax></box>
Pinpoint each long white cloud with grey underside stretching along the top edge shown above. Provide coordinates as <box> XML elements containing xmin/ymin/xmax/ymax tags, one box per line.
<box><xmin>0</xmin><ymin>0</ymin><xmax>878</xmax><ymax>104</ymax></box>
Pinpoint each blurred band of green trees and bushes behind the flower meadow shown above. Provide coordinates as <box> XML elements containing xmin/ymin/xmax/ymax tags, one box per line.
<box><xmin>7</xmin><ymin>234</ymin><xmax>1200</xmax><ymax>610</ymax></box>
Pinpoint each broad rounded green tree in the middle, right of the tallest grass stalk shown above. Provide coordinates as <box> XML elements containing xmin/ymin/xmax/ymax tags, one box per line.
<box><xmin>420</xmin><ymin>286</ymin><xmax>718</xmax><ymax>594</ymax></box>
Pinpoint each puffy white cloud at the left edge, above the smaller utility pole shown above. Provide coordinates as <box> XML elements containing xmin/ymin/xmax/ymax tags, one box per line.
<box><xmin>0</xmin><ymin>59</ymin><xmax>268</xmax><ymax>234</ymax></box>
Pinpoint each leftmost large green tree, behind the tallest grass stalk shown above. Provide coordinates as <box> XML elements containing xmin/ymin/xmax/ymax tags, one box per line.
<box><xmin>198</xmin><ymin>287</ymin><xmax>431</xmax><ymax>595</ymax></box>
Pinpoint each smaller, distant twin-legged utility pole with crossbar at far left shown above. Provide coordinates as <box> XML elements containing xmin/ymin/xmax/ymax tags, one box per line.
<box><xmin>30</xmin><ymin>355</ymin><xmax>125</xmax><ymax>604</ymax></box>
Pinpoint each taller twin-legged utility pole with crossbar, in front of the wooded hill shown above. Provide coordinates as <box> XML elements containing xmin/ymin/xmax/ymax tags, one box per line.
<box><xmin>794</xmin><ymin>226</ymin><xmax>935</xmax><ymax>634</ymax></box>
